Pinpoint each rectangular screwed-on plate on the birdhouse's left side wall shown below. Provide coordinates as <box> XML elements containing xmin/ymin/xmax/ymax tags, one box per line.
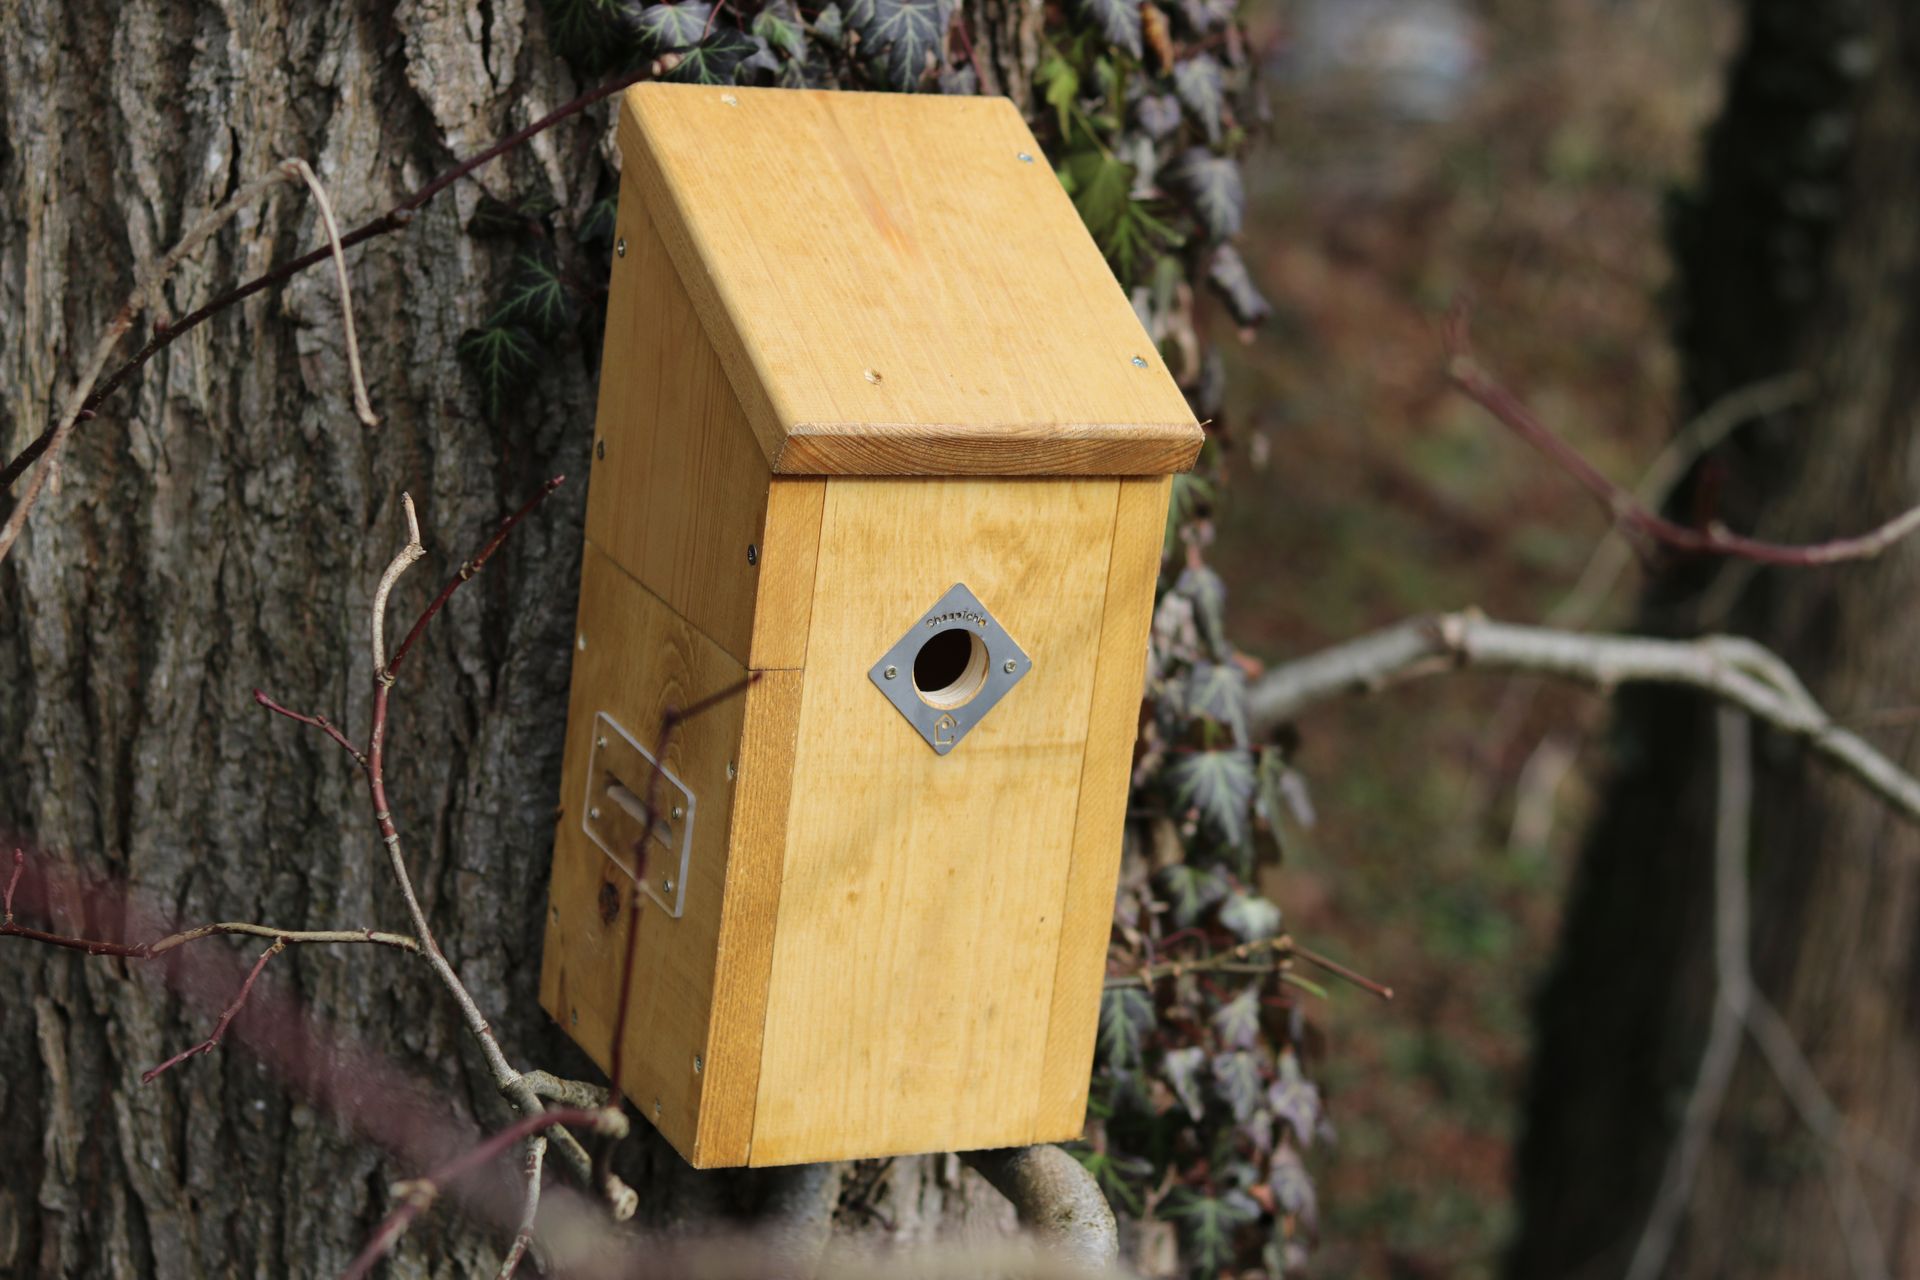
<box><xmin>580</xmin><ymin>712</ymin><xmax>693</xmax><ymax>919</ymax></box>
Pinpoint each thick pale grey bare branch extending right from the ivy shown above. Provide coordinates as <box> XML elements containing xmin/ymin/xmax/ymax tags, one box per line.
<box><xmin>1248</xmin><ymin>610</ymin><xmax>1920</xmax><ymax>821</ymax></box>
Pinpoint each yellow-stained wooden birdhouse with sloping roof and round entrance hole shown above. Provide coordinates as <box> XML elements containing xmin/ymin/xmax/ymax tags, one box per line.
<box><xmin>541</xmin><ymin>84</ymin><xmax>1202</xmax><ymax>1167</ymax></box>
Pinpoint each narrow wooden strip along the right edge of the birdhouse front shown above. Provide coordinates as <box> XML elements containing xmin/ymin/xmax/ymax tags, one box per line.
<box><xmin>1033</xmin><ymin>478</ymin><xmax>1173</xmax><ymax>1142</ymax></box>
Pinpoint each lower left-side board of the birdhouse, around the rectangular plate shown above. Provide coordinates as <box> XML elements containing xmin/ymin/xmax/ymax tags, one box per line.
<box><xmin>540</xmin><ymin>543</ymin><xmax>747</xmax><ymax>1161</ymax></box>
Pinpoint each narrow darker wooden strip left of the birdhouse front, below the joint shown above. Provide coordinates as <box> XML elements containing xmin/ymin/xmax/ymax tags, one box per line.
<box><xmin>693</xmin><ymin>667</ymin><xmax>812</xmax><ymax>1169</ymax></box>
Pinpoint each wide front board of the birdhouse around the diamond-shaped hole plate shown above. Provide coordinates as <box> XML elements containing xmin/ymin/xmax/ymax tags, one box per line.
<box><xmin>753</xmin><ymin>478</ymin><xmax>1119</xmax><ymax>1165</ymax></box>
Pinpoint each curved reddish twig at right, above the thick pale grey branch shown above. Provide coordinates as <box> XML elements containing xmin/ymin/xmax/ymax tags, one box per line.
<box><xmin>1448</xmin><ymin>309</ymin><xmax>1920</xmax><ymax>568</ymax></box>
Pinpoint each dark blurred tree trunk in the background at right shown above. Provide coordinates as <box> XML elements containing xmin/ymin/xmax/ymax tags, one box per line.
<box><xmin>1509</xmin><ymin>0</ymin><xmax>1920</xmax><ymax>1278</ymax></box>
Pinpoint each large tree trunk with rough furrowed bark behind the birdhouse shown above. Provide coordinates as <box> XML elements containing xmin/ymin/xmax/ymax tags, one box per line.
<box><xmin>0</xmin><ymin>0</ymin><xmax>1031</xmax><ymax>1276</ymax></box>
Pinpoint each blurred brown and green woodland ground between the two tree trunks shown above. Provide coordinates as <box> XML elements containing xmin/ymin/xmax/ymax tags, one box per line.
<box><xmin>1212</xmin><ymin>0</ymin><xmax>1740</xmax><ymax>1276</ymax></box>
